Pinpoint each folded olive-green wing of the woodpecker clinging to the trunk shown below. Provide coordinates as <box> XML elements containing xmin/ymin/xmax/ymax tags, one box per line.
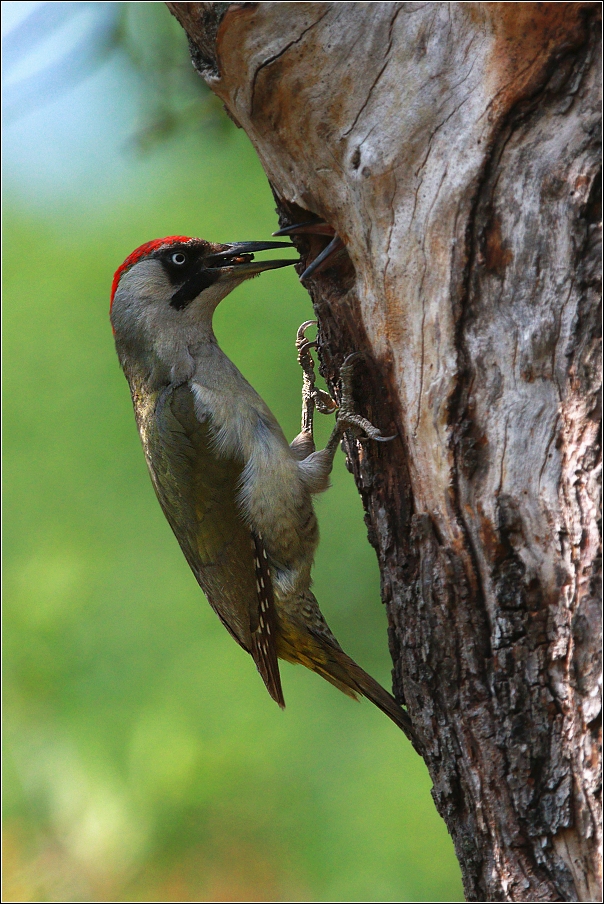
<box><xmin>135</xmin><ymin>385</ymin><xmax>284</xmax><ymax>706</ymax></box>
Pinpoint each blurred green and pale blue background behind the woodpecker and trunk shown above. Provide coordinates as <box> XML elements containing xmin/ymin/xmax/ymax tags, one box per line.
<box><xmin>3</xmin><ymin>3</ymin><xmax>462</xmax><ymax>901</ymax></box>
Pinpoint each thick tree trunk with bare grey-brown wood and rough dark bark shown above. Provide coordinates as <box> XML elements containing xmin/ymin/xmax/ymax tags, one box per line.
<box><xmin>168</xmin><ymin>3</ymin><xmax>600</xmax><ymax>901</ymax></box>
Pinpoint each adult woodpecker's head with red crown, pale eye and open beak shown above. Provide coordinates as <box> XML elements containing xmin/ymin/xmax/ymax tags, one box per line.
<box><xmin>110</xmin><ymin>235</ymin><xmax>297</xmax><ymax>372</ymax></box>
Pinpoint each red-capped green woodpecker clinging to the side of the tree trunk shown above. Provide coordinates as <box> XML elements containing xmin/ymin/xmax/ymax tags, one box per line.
<box><xmin>110</xmin><ymin>235</ymin><xmax>413</xmax><ymax>737</ymax></box>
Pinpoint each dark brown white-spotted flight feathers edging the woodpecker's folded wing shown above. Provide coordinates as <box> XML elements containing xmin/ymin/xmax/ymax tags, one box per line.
<box><xmin>251</xmin><ymin>534</ymin><xmax>285</xmax><ymax>709</ymax></box>
